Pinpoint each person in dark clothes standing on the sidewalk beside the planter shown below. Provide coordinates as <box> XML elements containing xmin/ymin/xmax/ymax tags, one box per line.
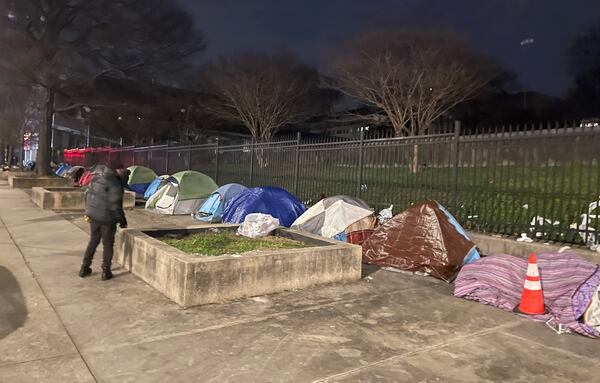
<box><xmin>79</xmin><ymin>165</ymin><xmax>129</xmax><ymax>281</ymax></box>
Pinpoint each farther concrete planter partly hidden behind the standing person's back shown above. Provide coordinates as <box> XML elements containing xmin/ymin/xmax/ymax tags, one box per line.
<box><xmin>31</xmin><ymin>187</ymin><xmax>135</xmax><ymax>211</ymax></box>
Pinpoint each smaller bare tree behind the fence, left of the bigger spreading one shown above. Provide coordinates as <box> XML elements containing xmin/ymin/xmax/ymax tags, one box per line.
<box><xmin>201</xmin><ymin>54</ymin><xmax>319</xmax><ymax>142</ymax></box>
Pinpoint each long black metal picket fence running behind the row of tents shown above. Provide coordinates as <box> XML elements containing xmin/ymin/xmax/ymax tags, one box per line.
<box><xmin>67</xmin><ymin>123</ymin><xmax>600</xmax><ymax>249</ymax></box>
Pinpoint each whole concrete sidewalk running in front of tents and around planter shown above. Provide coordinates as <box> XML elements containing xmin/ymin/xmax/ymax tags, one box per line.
<box><xmin>0</xmin><ymin>186</ymin><xmax>600</xmax><ymax>382</ymax></box>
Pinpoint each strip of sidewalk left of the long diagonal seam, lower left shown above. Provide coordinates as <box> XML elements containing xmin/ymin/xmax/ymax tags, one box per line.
<box><xmin>0</xmin><ymin>189</ymin><xmax>94</xmax><ymax>382</ymax></box>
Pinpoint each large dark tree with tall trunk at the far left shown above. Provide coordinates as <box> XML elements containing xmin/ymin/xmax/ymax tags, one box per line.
<box><xmin>0</xmin><ymin>0</ymin><xmax>204</xmax><ymax>174</ymax></box>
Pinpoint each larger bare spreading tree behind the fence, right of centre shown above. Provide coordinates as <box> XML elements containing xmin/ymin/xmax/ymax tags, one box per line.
<box><xmin>335</xmin><ymin>30</ymin><xmax>493</xmax><ymax>136</ymax></box>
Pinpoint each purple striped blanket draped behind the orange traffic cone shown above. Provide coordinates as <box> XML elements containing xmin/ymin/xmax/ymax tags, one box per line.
<box><xmin>454</xmin><ymin>253</ymin><xmax>600</xmax><ymax>337</ymax></box>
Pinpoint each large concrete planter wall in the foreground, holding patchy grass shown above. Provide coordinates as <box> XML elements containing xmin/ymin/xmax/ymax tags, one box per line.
<box><xmin>116</xmin><ymin>225</ymin><xmax>362</xmax><ymax>307</ymax></box>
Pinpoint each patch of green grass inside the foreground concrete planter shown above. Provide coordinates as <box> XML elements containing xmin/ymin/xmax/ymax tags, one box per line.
<box><xmin>158</xmin><ymin>231</ymin><xmax>305</xmax><ymax>256</ymax></box>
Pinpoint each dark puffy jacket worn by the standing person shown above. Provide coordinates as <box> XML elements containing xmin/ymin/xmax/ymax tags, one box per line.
<box><xmin>85</xmin><ymin>168</ymin><xmax>127</xmax><ymax>226</ymax></box>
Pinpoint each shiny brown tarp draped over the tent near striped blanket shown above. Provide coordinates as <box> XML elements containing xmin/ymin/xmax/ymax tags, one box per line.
<box><xmin>363</xmin><ymin>201</ymin><xmax>475</xmax><ymax>282</ymax></box>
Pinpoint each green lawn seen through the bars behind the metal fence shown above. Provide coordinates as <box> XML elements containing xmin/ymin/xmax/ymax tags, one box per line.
<box><xmin>213</xmin><ymin>162</ymin><xmax>600</xmax><ymax>243</ymax></box>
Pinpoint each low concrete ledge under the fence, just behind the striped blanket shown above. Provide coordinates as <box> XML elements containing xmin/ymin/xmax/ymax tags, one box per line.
<box><xmin>469</xmin><ymin>232</ymin><xmax>600</xmax><ymax>263</ymax></box>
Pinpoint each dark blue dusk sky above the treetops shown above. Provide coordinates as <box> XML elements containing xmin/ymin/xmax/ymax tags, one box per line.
<box><xmin>179</xmin><ymin>0</ymin><xmax>600</xmax><ymax>96</ymax></box>
